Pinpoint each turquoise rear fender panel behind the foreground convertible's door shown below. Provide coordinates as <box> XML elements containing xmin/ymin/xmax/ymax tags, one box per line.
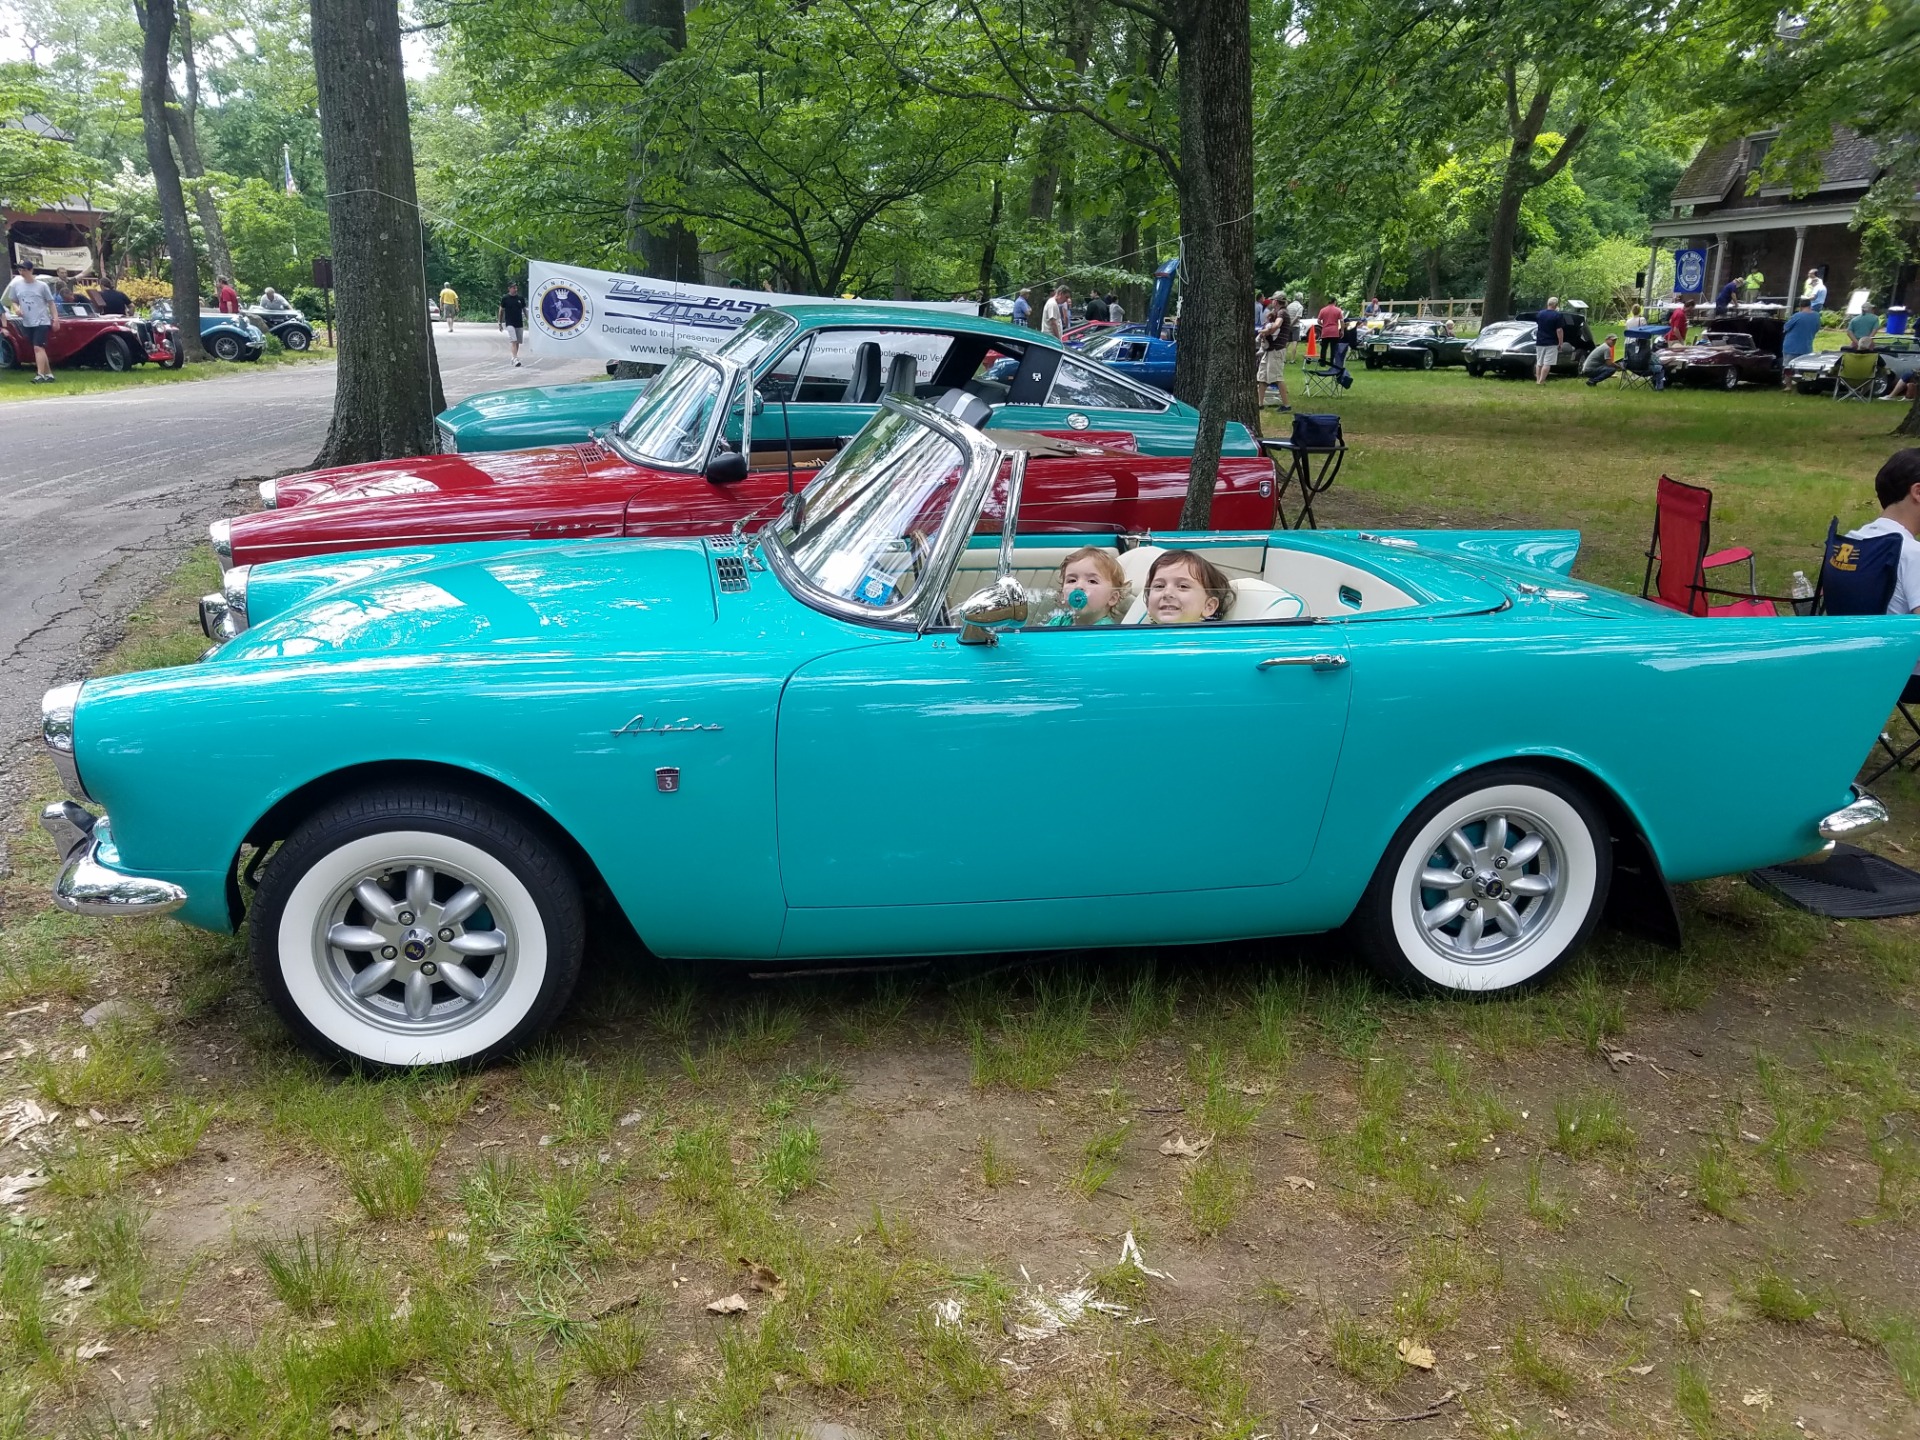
<box><xmin>1302</xmin><ymin>599</ymin><xmax>1920</xmax><ymax>920</ymax></box>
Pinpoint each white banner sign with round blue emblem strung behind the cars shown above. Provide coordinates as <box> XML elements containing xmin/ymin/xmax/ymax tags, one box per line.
<box><xmin>526</xmin><ymin>259</ymin><xmax>977</xmax><ymax>363</ymax></box>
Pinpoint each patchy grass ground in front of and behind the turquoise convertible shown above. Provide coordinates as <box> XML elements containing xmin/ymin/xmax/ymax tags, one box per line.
<box><xmin>0</xmin><ymin>389</ymin><xmax>1920</xmax><ymax>1440</ymax></box>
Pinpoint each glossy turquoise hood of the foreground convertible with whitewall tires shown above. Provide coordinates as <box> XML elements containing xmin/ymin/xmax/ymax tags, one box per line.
<box><xmin>211</xmin><ymin>540</ymin><xmax>714</xmax><ymax>662</ymax></box>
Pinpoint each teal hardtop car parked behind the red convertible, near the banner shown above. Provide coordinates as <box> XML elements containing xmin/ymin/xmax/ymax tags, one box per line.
<box><xmin>436</xmin><ymin>301</ymin><xmax>1260</xmax><ymax>455</ymax></box>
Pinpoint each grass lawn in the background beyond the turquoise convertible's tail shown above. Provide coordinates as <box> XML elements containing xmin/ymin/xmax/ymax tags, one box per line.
<box><xmin>1261</xmin><ymin>369</ymin><xmax>1912</xmax><ymax>595</ymax></box>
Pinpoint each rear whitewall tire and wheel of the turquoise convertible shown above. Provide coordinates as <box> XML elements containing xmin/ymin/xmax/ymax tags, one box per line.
<box><xmin>1354</xmin><ymin>766</ymin><xmax>1613</xmax><ymax>993</ymax></box>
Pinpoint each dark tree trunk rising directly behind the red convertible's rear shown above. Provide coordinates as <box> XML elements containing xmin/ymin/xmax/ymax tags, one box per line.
<box><xmin>1175</xmin><ymin>0</ymin><xmax>1258</xmax><ymax>530</ymax></box>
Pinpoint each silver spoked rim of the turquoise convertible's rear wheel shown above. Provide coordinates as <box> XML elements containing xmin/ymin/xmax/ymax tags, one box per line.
<box><xmin>1407</xmin><ymin>806</ymin><xmax>1567</xmax><ymax>966</ymax></box>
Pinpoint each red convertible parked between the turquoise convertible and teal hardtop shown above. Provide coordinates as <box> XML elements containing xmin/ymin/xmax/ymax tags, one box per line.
<box><xmin>211</xmin><ymin>351</ymin><xmax>1275</xmax><ymax>587</ymax></box>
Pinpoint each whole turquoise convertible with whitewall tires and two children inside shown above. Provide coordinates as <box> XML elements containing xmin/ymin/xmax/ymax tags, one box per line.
<box><xmin>42</xmin><ymin>399</ymin><xmax>1920</xmax><ymax>1066</ymax></box>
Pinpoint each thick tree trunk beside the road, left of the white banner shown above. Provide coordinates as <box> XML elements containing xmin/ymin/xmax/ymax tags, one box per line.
<box><xmin>313</xmin><ymin>0</ymin><xmax>445</xmax><ymax>467</ymax></box>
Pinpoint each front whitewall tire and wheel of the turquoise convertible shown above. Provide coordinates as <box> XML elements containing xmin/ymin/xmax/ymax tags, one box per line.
<box><xmin>252</xmin><ymin>789</ymin><xmax>584</xmax><ymax>1066</ymax></box>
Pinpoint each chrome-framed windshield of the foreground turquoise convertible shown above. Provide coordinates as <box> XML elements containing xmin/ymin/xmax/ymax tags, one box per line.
<box><xmin>762</xmin><ymin>409</ymin><xmax>973</xmax><ymax>612</ymax></box>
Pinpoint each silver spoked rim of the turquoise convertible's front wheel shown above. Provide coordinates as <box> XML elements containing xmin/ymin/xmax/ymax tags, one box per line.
<box><xmin>313</xmin><ymin>858</ymin><xmax>518</xmax><ymax>1035</ymax></box>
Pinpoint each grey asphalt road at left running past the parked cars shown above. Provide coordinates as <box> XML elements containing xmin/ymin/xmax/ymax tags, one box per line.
<box><xmin>0</xmin><ymin>324</ymin><xmax>591</xmax><ymax>874</ymax></box>
